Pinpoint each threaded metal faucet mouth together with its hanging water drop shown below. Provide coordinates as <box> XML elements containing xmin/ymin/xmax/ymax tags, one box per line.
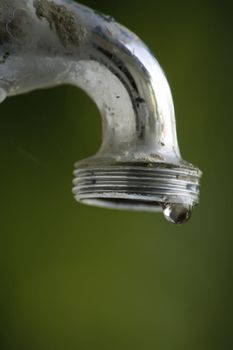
<box><xmin>73</xmin><ymin>162</ymin><xmax>201</xmax><ymax>224</ymax></box>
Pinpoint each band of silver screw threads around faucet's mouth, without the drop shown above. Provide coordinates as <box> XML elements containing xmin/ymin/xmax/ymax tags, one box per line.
<box><xmin>73</xmin><ymin>166</ymin><xmax>199</xmax><ymax>206</ymax></box>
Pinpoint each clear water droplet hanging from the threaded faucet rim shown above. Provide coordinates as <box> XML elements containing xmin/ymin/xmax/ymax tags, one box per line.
<box><xmin>163</xmin><ymin>203</ymin><xmax>192</xmax><ymax>224</ymax></box>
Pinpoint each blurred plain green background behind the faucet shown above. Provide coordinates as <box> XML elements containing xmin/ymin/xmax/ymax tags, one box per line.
<box><xmin>0</xmin><ymin>0</ymin><xmax>233</xmax><ymax>350</ymax></box>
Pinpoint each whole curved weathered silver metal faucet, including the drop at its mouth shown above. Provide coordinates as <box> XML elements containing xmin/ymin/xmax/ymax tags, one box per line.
<box><xmin>0</xmin><ymin>0</ymin><xmax>201</xmax><ymax>224</ymax></box>
